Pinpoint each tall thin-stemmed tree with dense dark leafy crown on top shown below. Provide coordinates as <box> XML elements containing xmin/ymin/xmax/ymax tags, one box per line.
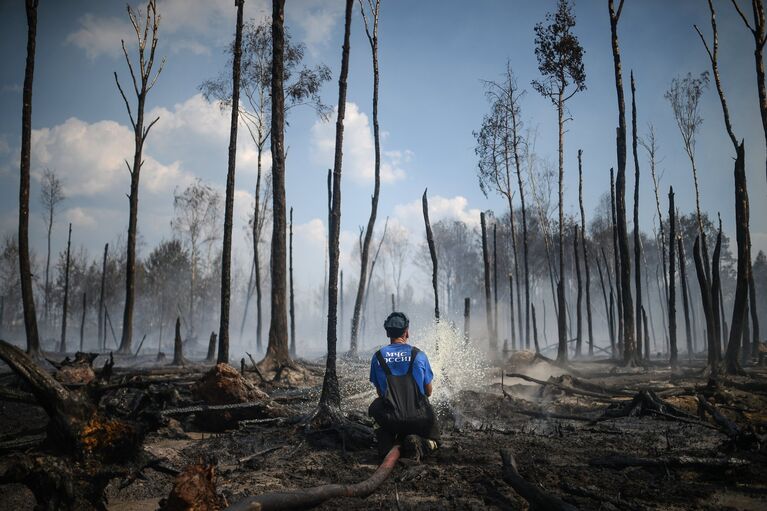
<box><xmin>532</xmin><ymin>0</ymin><xmax>586</xmax><ymax>363</ymax></box>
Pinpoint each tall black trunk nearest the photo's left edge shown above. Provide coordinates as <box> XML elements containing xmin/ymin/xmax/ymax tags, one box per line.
<box><xmin>19</xmin><ymin>0</ymin><xmax>40</xmax><ymax>357</ymax></box>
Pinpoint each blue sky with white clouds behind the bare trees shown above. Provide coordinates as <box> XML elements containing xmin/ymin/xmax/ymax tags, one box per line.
<box><xmin>0</xmin><ymin>0</ymin><xmax>767</xmax><ymax>300</ymax></box>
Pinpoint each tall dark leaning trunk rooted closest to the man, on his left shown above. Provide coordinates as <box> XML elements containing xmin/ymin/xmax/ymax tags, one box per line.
<box><xmin>316</xmin><ymin>0</ymin><xmax>354</xmax><ymax>423</ymax></box>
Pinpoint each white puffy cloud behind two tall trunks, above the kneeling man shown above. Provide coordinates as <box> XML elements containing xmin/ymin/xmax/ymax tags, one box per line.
<box><xmin>311</xmin><ymin>103</ymin><xmax>413</xmax><ymax>184</ymax></box>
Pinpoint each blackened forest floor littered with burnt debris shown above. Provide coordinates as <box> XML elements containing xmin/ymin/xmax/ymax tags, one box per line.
<box><xmin>0</xmin><ymin>346</ymin><xmax>767</xmax><ymax>511</ymax></box>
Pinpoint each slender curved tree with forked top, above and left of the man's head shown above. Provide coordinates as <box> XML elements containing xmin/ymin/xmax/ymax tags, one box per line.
<box><xmin>350</xmin><ymin>0</ymin><xmax>382</xmax><ymax>355</ymax></box>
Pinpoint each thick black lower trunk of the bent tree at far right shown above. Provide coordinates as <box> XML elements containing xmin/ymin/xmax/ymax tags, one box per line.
<box><xmin>725</xmin><ymin>143</ymin><xmax>751</xmax><ymax>374</ymax></box>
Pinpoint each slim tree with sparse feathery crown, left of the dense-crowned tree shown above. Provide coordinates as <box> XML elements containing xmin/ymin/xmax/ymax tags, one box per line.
<box><xmin>474</xmin><ymin>63</ymin><xmax>530</xmax><ymax>348</ymax></box>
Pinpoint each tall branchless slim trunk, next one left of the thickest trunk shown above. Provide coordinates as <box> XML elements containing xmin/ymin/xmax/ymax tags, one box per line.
<box><xmin>217</xmin><ymin>0</ymin><xmax>245</xmax><ymax>364</ymax></box>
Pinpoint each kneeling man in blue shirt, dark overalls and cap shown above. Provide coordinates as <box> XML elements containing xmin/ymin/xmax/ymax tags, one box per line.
<box><xmin>368</xmin><ymin>312</ymin><xmax>439</xmax><ymax>460</ymax></box>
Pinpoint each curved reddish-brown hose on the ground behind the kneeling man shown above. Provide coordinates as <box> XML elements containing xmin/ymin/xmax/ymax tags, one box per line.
<box><xmin>226</xmin><ymin>445</ymin><xmax>402</xmax><ymax>511</ymax></box>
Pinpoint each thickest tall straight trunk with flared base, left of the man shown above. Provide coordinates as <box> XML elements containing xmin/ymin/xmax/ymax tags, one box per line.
<box><xmin>262</xmin><ymin>0</ymin><xmax>292</xmax><ymax>367</ymax></box>
